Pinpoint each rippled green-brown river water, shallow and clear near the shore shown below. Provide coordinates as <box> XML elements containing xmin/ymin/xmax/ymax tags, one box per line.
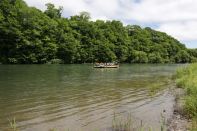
<box><xmin>0</xmin><ymin>64</ymin><xmax>182</xmax><ymax>131</ymax></box>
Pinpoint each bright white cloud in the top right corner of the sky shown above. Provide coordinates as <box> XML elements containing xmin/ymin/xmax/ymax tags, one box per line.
<box><xmin>127</xmin><ymin>0</ymin><xmax>197</xmax><ymax>22</ymax></box>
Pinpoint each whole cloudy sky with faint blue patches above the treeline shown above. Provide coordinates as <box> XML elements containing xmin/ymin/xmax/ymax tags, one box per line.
<box><xmin>25</xmin><ymin>0</ymin><xmax>197</xmax><ymax>48</ymax></box>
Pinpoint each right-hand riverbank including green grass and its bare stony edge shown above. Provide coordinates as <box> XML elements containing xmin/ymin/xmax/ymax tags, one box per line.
<box><xmin>169</xmin><ymin>64</ymin><xmax>197</xmax><ymax>131</ymax></box>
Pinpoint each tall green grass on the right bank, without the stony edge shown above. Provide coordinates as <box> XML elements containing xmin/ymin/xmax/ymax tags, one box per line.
<box><xmin>176</xmin><ymin>63</ymin><xmax>197</xmax><ymax>131</ymax></box>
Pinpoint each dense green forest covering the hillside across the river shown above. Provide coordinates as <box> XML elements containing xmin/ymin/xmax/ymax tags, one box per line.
<box><xmin>0</xmin><ymin>0</ymin><xmax>197</xmax><ymax>64</ymax></box>
